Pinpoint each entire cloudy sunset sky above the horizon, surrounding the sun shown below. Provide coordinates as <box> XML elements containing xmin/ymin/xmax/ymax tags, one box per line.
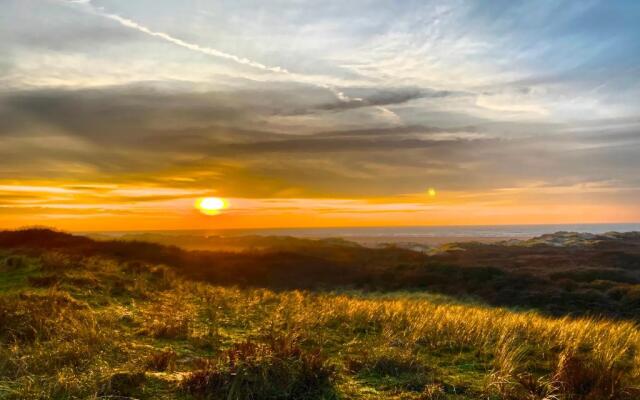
<box><xmin>0</xmin><ymin>0</ymin><xmax>640</xmax><ymax>231</ymax></box>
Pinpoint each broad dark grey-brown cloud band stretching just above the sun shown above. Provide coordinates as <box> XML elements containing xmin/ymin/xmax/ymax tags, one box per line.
<box><xmin>0</xmin><ymin>84</ymin><xmax>640</xmax><ymax>201</ymax></box>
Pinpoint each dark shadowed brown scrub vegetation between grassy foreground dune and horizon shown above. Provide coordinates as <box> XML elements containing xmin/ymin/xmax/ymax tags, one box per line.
<box><xmin>0</xmin><ymin>229</ymin><xmax>640</xmax><ymax>320</ymax></box>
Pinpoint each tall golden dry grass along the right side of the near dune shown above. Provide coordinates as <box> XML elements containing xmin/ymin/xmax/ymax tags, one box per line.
<box><xmin>192</xmin><ymin>286</ymin><xmax>640</xmax><ymax>400</ymax></box>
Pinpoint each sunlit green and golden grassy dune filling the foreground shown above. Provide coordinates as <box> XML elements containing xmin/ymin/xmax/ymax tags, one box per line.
<box><xmin>0</xmin><ymin>251</ymin><xmax>640</xmax><ymax>400</ymax></box>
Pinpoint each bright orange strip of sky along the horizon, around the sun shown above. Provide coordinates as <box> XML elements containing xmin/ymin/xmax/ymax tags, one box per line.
<box><xmin>0</xmin><ymin>183</ymin><xmax>640</xmax><ymax>231</ymax></box>
